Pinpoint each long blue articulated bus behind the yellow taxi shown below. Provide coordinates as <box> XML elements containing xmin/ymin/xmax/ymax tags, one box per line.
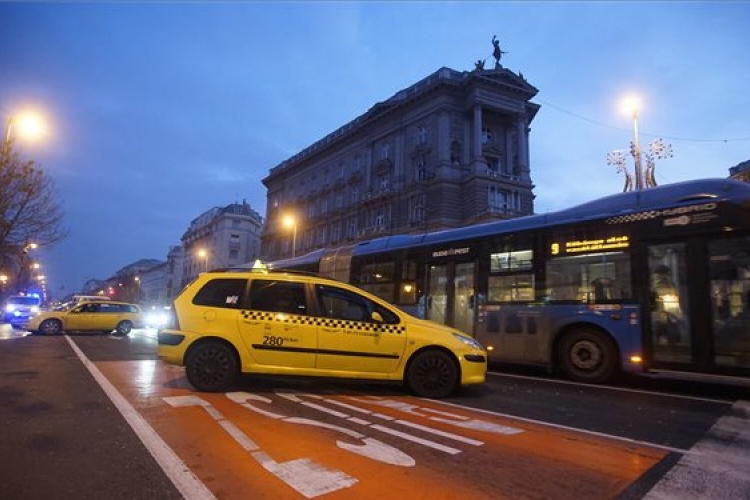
<box><xmin>269</xmin><ymin>179</ymin><xmax>750</xmax><ymax>383</ymax></box>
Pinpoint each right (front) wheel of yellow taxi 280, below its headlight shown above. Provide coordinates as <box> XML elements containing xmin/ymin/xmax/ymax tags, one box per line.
<box><xmin>406</xmin><ymin>350</ymin><xmax>458</xmax><ymax>398</ymax></box>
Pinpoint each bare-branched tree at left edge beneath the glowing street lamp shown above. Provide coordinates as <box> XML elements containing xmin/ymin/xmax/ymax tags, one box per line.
<box><xmin>0</xmin><ymin>138</ymin><xmax>67</xmax><ymax>292</ymax></box>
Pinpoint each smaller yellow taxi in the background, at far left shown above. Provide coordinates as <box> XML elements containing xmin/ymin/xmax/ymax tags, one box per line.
<box><xmin>25</xmin><ymin>300</ymin><xmax>143</xmax><ymax>335</ymax></box>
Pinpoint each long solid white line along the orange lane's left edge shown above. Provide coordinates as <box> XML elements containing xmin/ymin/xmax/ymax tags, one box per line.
<box><xmin>65</xmin><ymin>335</ymin><xmax>216</xmax><ymax>500</ymax></box>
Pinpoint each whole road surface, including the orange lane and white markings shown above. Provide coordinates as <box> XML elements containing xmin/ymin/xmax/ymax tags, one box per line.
<box><xmin>0</xmin><ymin>327</ymin><xmax>750</xmax><ymax>500</ymax></box>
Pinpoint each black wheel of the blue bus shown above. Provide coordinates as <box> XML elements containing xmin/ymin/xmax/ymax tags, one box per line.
<box><xmin>560</xmin><ymin>328</ymin><xmax>618</xmax><ymax>384</ymax></box>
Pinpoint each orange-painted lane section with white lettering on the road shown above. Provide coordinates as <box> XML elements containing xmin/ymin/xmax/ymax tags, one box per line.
<box><xmin>95</xmin><ymin>361</ymin><xmax>667</xmax><ymax>500</ymax></box>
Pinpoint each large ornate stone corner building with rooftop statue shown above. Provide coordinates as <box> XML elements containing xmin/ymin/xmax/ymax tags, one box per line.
<box><xmin>262</xmin><ymin>64</ymin><xmax>539</xmax><ymax>260</ymax></box>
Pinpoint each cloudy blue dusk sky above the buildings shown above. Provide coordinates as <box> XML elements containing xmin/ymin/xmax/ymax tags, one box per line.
<box><xmin>0</xmin><ymin>0</ymin><xmax>750</xmax><ymax>296</ymax></box>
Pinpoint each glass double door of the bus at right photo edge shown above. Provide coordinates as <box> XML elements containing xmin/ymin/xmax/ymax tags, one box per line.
<box><xmin>647</xmin><ymin>236</ymin><xmax>750</xmax><ymax>375</ymax></box>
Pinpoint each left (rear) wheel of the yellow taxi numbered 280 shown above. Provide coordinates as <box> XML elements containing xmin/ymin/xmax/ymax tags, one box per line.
<box><xmin>185</xmin><ymin>341</ymin><xmax>239</xmax><ymax>392</ymax></box>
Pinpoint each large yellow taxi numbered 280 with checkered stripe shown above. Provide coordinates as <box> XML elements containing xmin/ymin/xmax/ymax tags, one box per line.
<box><xmin>158</xmin><ymin>270</ymin><xmax>487</xmax><ymax>398</ymax></box>
